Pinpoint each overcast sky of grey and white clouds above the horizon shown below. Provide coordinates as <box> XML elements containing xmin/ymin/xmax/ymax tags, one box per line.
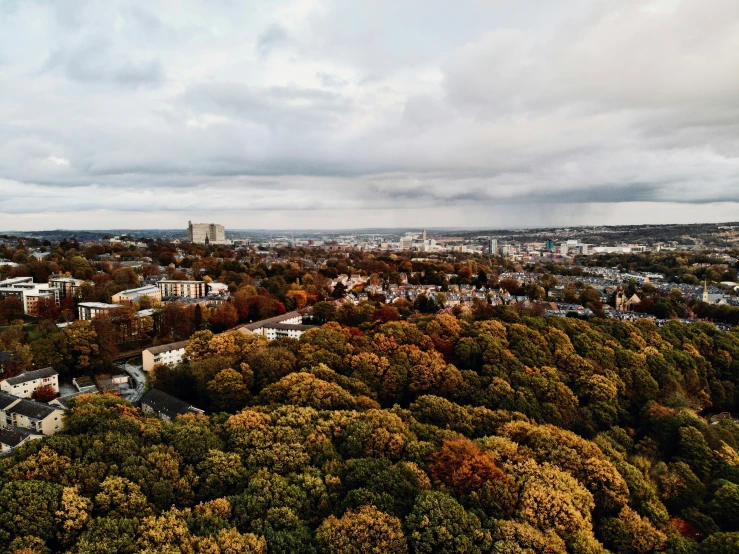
<box><xmin>0</xmin><ymin>0</ymin><xmax>739</xmax><ymax>231</ymax></box>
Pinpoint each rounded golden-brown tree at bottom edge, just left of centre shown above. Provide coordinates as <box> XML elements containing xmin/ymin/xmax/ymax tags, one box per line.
<box><xmin>316</xmin><ymin>506</ymin><xmax>408</xmax><ymax>554</ymax></box>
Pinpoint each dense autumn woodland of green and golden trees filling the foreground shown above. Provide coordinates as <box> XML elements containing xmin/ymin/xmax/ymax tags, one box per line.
<box><xmin>0</xmin><ymin>311</ymin><xmax>739</xmax><ymax>554</ymax></box>
